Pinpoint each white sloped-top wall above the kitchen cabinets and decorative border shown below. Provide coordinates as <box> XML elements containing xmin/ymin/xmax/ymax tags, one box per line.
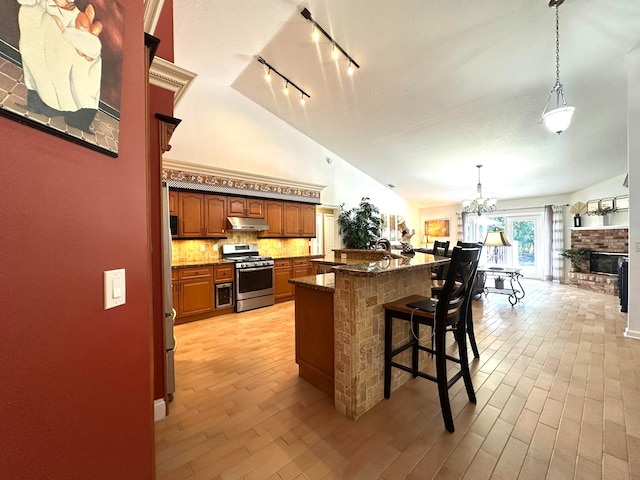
<box><xmin>169</xmin><ymin>80</ymin><xmax>417</xmax><ymax>238</ymax></box>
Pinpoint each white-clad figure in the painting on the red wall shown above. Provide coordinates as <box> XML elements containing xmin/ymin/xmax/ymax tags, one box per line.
<box><xmin>17</xmin><ymin>0</ymin><xmax>103</xmax><ymax>133</ymax></box>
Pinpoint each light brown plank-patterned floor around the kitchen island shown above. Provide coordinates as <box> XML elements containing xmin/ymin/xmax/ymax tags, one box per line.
<box><xmin>156</xmin><ymin>280</ymin><xmax>640</xmax><ymax>480</ymax></box>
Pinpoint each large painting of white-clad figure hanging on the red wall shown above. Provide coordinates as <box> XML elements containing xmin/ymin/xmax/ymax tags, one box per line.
<box><xmin>0</xmin><ymin>0</ymin><xmax>124</xmax><ymax>157</ymax></box>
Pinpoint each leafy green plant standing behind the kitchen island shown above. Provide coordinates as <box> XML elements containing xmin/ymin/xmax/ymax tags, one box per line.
<box><xmin>338</xmin><ymin>197</ymin><xmax>382</xmax><ymax>249</ymax></box>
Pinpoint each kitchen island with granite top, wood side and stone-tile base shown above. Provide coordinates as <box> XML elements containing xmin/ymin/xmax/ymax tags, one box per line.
<box><xmin>290</xmin><ymin>250</ymin><xmax>450</xmax><ymax>419</ymax></box>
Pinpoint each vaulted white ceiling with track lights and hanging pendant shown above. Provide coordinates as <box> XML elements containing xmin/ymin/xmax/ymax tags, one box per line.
<box><xmin>173</xmin><ymin>0</ymin><xmax>640</xmax><ymax>206</ymax></box>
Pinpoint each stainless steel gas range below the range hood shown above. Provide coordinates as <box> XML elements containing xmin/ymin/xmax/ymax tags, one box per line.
<box><xmin>222</xmin><ymin>243</ymin><xmax>275</xmax><ymax>312</ymax></box>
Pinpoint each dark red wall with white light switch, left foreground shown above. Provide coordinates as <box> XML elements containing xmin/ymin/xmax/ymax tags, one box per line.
<box><xmin>0</xmin><ymin>1</ymin><xmax>154</xmax><ymax>479</ymax></box>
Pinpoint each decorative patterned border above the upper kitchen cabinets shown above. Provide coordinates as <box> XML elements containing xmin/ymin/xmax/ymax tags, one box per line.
<box><xmin>162</xmin><ymin>168</ymin><xmax>320</xmax><ymax>203</ymax></box>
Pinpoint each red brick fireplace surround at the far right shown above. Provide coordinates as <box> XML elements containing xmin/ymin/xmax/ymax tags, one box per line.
<box><xmin>569</xmin><ymin>226</ymin><xmax>629</xmax><ymax>295</ymax></box>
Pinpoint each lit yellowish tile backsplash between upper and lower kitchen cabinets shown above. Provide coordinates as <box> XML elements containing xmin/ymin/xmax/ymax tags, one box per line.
<box><xmin>171</xmin><ymin>232</ymin><xmax>309</xmax><ymax>265</ymax></box>
